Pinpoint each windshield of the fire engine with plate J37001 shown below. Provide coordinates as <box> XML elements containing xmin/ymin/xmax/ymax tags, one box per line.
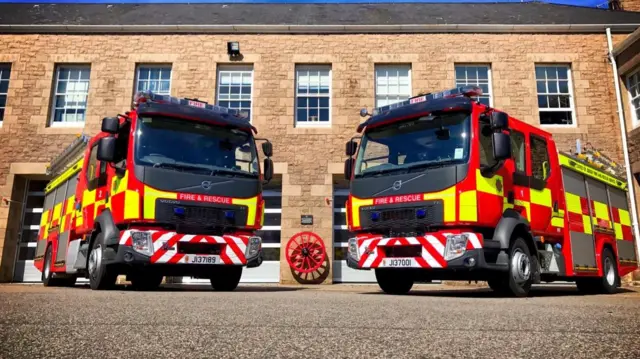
<box><xmin>355</xmin><ymin>112</ymin><xmax>470</xmax><ymax>177</ymax></box>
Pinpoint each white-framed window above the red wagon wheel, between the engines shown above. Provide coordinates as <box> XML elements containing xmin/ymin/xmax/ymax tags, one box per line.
<box><xmin>295</xmin><ymin>66</ymin><xmax>331</xmax><ymax>126</ymax></box>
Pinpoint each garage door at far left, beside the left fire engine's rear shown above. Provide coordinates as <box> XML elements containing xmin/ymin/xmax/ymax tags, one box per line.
<box><xmin>13</xmin><ymin>180</ymin><xmax>47</xmax><ymax>282</ymax></box>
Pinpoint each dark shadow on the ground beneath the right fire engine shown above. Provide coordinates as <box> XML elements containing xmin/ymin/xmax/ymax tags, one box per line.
<box><xmin>360</xmin><ymin>286</ymin><xmax>635</xmax><ymax>298</ymax></box>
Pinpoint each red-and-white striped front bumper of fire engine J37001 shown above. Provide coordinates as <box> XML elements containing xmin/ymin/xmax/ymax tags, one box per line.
<box><xmin>347</xmin><ymin>232</ymin><xmax>504</xmax><ymax>270</ymax></box>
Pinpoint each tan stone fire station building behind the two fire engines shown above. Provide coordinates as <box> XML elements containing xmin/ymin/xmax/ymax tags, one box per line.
<box><xmin>0</xmin><ymin>3</ymin><xmax>640</xmax><ymax>283</ymax></box>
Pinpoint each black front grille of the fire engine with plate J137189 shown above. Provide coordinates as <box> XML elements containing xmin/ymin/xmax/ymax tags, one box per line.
<box><xmin>156</xmin><ymin>200</ymin><xmax>247</xmax><ymax>234</ymax></box>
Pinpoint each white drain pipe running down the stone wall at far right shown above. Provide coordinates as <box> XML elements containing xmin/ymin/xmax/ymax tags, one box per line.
<box><xmin>607</xmin><ymin>28</ymin><xmax>640</xmax><ymax>258</ymax></box>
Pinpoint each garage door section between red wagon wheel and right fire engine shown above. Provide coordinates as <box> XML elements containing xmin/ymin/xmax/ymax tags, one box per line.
<box><xmin>333</xmin><ymin>187</ymin><xmax>376</xmax><ymax>283</ymax></box>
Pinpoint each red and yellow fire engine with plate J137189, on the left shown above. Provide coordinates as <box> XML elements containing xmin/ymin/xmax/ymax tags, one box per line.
<box><xmin>35</xmin><ymin>92</ymin><xmax>273</xmax><ymax>290</ymax></box>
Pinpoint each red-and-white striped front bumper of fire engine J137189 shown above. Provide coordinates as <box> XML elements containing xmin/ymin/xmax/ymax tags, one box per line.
<box><xmin>108</xmin><ymin>230</ymin><xmax>264</xmax><ymax>268</ymax></box>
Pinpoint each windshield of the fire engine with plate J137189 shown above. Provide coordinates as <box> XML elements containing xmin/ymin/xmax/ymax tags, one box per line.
<box><xmin>135</xmin><ymin>116</ymin><xmax>258</xmax><ymax>177</ymax></box>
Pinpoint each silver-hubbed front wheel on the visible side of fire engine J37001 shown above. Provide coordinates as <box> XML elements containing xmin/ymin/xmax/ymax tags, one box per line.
<box><xmin>504</xmin><ymin>237</ymin><xmax>536</xmax><ymax>297</ymax></box>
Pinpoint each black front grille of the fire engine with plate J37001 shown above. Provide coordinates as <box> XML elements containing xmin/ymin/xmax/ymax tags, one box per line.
<box><xmin>360</xmin><ymin>200</ymin><xmax>444</xmax><ymax>230</ymax></box>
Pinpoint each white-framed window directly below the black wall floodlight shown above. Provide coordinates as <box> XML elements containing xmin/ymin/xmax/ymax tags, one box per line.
<box><xmin>216</xmin><ymin>66</ymin><xmax>253</xmax><ymax>119</ymax></box>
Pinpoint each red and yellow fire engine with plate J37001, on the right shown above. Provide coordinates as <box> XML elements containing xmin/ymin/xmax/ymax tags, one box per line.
<box><xmin>345</xmin><ymin>86</ymin><xmax>638</xmax><ymax>296</ymax></box>
